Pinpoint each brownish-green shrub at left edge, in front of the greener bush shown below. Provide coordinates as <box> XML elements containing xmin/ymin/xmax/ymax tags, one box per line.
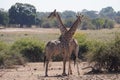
<box><xmin>0</xmin><ymin>50</ymin><xmax>25</xmax><ymax>68</ymax></box>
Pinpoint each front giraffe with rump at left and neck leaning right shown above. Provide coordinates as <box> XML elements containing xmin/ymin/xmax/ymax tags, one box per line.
<box><xmin>44</xmin><ymin>12</ymin><xmax>81</xmax><ymax>76</ymax></box>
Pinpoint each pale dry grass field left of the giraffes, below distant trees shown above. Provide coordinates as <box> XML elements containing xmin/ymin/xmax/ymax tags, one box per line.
<box><xmin>0</xmin><ymin>28</ymin><xmax>59</xmax><ymax>43</ymax></box>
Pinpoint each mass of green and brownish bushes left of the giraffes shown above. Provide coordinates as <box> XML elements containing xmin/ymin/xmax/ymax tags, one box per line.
<box><xmin>0</xmin><ymin>38</ymin><xmax>44</xmax><ymax>68</ymax></box>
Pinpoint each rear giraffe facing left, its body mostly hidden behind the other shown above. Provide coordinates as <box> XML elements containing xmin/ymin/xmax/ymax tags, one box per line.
<box><xmin>48</xmin><ymin>9</ymin><xmax>80</xmax><ymax>75</ymax></box>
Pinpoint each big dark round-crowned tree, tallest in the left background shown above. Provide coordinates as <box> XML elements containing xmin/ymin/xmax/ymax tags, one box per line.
<box><xmin>9</xmin><ymin>3</ymin><xmax>36</xmax><ymax>27</ymax></box>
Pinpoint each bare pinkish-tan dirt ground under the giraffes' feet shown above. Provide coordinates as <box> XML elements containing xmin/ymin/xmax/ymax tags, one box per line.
<box><xmin>0</xmin><ymin>62</ymin><xmax>120</xmax><ymax>80</ymax></box>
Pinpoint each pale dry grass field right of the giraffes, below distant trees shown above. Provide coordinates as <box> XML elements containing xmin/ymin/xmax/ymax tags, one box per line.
<box><xmin>78</xmin><ymin>28</ymin><xmax>120</xmax><ymax>42</ymax></box>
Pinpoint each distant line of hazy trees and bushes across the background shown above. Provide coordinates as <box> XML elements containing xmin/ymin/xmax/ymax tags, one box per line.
<box><xmin>0</xmin><ymin>3</ymin><xmax>120</xmax><ymax>30</ymax></box>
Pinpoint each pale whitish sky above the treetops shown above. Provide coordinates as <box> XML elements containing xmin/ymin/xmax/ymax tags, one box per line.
<box><xmin>0</xmin><ymin>0</ymin><xmax>120</xmax><ymax>12</ymax></box>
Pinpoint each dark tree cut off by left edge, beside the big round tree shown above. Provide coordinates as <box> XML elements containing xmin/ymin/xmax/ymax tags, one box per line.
<box><xmin>0</xmin><ymin>9</ymin><xmax>9</xmax><ymax>26</ymax></box>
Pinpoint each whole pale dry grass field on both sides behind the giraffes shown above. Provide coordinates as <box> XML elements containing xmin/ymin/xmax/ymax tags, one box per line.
<box><xmin>0</xmin><ymin>28</ymin><xmax>120</xmax><ymax>43</ymax></box>
